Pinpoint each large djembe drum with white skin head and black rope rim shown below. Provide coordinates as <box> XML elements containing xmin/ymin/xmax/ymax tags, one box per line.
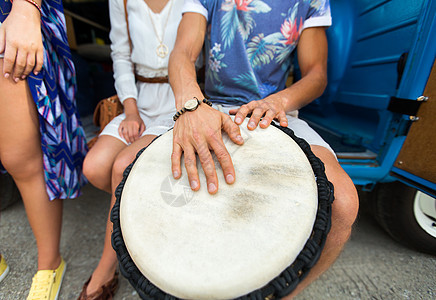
<box><xmin>111</xmin><ymin>123</ymin><xmax>333</xmax><ymax>299</ymax></box>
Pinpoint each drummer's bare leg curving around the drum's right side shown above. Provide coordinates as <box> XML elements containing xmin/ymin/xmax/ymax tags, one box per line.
<box><xmin>285</xmin><ymin>146</ymin><xmax>359</xmax><ymax>299</ymax></box>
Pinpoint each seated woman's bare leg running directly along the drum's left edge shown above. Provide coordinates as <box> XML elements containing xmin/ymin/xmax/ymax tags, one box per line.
<box><xmin>86</xmin><ymin>135</ymin><xmax>155</xmax><ymax>295</ymax></box>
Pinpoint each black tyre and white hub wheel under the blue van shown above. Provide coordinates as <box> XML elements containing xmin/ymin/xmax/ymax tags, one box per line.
<box><xmin>371</xmin><ymin>182</ymin><xmax>436</xmax><ymax>255</ymax></box>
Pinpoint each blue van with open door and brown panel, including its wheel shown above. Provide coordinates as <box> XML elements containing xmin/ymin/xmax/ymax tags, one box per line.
<box><xmin>300</xmin><ymin>0</ymin><xmax>436</xmax><ymax>254</ymax></box>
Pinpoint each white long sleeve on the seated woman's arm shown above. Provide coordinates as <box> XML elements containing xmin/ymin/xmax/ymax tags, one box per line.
<box><xmin>109</xmin><ymin>0</ymin><xmax>138</xmax><ymax>103</ymax></box>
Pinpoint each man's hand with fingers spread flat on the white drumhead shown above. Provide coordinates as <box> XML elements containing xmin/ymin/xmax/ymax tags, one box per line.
<box><xmin>171</xmin><ymin>104</ymin><xmax>244</xmax><ymax>194</ymax></box>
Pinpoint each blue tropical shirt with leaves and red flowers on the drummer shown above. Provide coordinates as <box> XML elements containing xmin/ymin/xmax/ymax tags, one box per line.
<box><xmin>183</xmin><ymin>0</ymin><xmax>331</xmax><ymax>105</ymax></box>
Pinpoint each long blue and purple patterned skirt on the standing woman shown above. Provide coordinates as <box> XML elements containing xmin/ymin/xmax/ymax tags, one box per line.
<box><xmin>0</xmin><ymin>0</ymin><xmax>87</xmax><ymax>200</ymax></box>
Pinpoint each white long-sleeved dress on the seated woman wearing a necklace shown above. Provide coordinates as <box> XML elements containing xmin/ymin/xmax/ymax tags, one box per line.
<box><xmin>100</xmin><ymin>0</ymin><xmax>183</xmax><ymax>144</ymax></box>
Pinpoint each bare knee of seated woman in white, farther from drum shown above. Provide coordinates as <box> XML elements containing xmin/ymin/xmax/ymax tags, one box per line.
<box><xmin>83</xmin><ymin>135</ymin><xmax>127</xmax><ymax>193</ymax></box>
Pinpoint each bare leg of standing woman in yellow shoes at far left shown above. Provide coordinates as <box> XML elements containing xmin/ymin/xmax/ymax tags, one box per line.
<box><xmin>0</xmin><ymin>59</ymin><xmax>62</xmax><ymax>270</ymax></box>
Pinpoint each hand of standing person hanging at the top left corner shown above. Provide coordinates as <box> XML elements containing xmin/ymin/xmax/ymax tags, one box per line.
<box><xmin>0</xmin><ymin>0</ymin><xmax>44</xmax><ymax>82</ymax></box>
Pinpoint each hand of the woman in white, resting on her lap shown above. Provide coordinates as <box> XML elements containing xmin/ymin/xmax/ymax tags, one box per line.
<box><xmin>118</xmin><ymin>98</ymin><xmax>145</xmax><ymax>144</ymax></box>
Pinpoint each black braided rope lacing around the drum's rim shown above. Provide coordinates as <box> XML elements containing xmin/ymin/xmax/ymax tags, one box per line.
<box><xmin>111</xmin><ymin>123</ymin><xmax>334</xmax><ymax>300</ymax></box>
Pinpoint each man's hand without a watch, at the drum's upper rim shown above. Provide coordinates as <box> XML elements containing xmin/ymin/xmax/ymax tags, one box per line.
<box><xmin>229</xmin><ymin>94</ymin><xmax>288</xmax><ymax>130</ymax></box>
